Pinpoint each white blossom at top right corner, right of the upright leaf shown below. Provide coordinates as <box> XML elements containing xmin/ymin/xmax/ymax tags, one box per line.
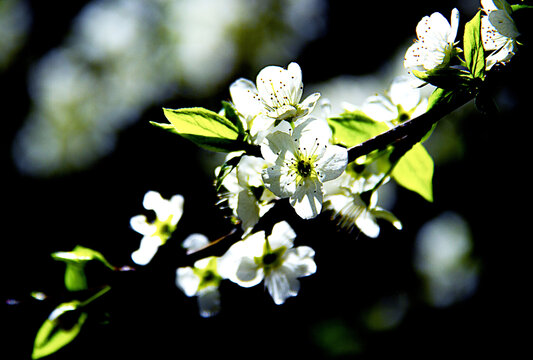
<box><xmin>481</xmin><ymin>0</ymin><xmax>520</xmax><ymax>70</ymax></box>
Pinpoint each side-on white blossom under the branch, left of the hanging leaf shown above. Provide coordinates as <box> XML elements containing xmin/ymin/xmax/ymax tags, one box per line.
<box><xmin>324</xmin><ymin>172</ymin><xmax>402</xmax><ymax>238</ymax></box>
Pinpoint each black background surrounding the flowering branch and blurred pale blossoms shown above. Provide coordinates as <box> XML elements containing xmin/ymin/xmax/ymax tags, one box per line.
<box><xmin>0</xmin><ymin>1</ymin><xmax>532</xmax><ymax>359</ymax></box>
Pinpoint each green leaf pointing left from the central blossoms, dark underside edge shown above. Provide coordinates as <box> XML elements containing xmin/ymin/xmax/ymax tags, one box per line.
<box><xmin>160</xmin><ymin>108</ymin><xmax>245</xmax><ymax>152</ymax></box>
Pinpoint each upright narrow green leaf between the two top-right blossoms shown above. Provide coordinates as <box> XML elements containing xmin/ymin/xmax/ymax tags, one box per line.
<box><xmin>463</xmin><ymin>10</ymin><xmax>485</xmax><ymax>79</ymax></box>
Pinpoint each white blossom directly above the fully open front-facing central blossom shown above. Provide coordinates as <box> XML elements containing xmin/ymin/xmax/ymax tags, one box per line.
<box><xmin>230</xmin><ymin>62</ymin><xmax>320</xmax><ymax>144</ymax></box>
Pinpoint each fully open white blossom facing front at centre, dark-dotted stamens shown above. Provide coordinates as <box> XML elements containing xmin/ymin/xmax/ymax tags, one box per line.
<box><xmin>261</xmin><ymin>118</ymin><xmax>348</xmax><ymax>219</ymax></box>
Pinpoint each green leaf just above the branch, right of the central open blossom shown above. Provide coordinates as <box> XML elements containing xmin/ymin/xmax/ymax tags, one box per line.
<box><xmin>328</xmin><ymin>111</ymin><xmax>389</xmax><ymax>147</ymax></box>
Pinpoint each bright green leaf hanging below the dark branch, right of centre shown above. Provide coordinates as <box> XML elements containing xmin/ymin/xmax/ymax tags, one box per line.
<box><xmin>391</xmin><ymin>143</ymin><xmax>434</xmax><ymax>202</ymax></box>
